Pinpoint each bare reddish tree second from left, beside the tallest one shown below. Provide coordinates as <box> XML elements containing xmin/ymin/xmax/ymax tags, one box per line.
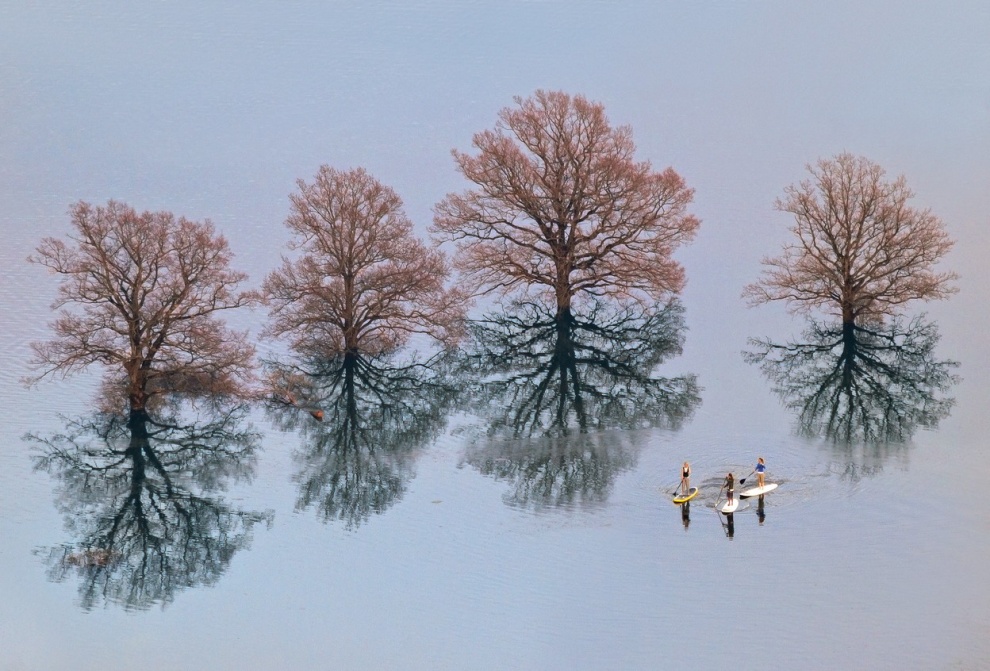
<box><xmin>264</xmin><ymin>166</ymin><xmax>465</xmax><ymax>358</ymax></box>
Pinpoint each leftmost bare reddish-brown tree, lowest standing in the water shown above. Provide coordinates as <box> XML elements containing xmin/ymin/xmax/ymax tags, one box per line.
<box><xmin>28</xmin><ymin>201</ymin><xmax>254</xmax><ymax>417</ymax></box>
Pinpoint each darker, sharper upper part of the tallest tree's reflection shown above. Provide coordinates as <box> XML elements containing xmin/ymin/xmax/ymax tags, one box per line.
<box><xmin>465</xmin><ymin>301</ymin><xmax>700</xmax><ymax>436</ymax></box>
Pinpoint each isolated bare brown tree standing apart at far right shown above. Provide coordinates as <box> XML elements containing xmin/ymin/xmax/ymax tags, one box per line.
<box><xmin>744</xmin><ymin>153</ymin><xmax>957</xmax><ymax>324</ymax></box>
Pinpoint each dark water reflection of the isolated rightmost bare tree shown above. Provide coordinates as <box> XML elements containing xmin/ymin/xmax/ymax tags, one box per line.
<box><xmin>744</xmin><ymin>317</ymin><xmax>958</xmax><ymax>444</ymax></box>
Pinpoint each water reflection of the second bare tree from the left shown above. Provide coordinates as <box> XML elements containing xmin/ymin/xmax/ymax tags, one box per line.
<box><xmin>269</xmin><ymin>354</ymin><xmax>462</xmax><ymax>527</ymax></box>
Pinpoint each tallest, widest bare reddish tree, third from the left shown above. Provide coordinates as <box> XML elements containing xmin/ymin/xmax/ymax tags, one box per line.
<box><xmin>434</xmin><ymin>91</ymin><xmax>700</xmax><ymax>316</ymax></box>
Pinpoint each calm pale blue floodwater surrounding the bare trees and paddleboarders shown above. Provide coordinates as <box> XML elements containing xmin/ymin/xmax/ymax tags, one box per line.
<box><xmin>0</xmin><ymin>0</ymin><xmax>990</xmax><ymax>671</ymax></box>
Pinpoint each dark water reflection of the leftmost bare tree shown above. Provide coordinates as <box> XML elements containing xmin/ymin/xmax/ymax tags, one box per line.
<box><xmin>28</xmin><ymin>411</ymin><xmax>271</xmax><ymax>610</ymax></box>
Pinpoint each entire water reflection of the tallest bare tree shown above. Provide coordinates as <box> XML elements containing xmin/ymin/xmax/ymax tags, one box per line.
<box><xmin>462</xmin><ymin>302</ymin><xmax>700</xmax><ymax>508</ymax></box>
